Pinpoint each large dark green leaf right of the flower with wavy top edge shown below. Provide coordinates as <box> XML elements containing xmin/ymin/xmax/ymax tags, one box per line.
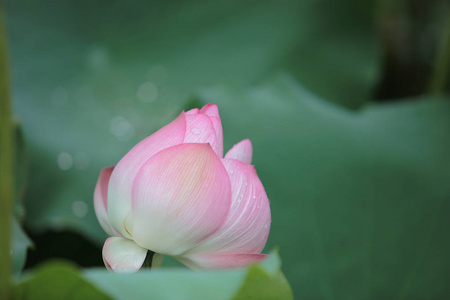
<box><xmin>198</xmin><ymin>75</ymin><xmax>450</xmax><ymax>299</ymax></box>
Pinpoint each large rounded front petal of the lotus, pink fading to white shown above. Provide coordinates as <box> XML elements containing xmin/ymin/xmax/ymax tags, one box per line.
<box><xmin>132</xmin><ymin>144</ymin><xmax>231</xmax><ymax>255</ymax></box>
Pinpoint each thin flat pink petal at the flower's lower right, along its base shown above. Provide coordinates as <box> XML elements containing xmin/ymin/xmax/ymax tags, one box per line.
<box><xmin>175</xmin><ymin>253</ymin><xmax>268</xmax><ymax>270</ymax></box>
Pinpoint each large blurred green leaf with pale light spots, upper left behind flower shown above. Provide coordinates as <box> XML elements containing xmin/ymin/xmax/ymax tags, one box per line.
<box><xmin>5</xmin><ymin>0</ymin><xmax>378</xmax><ymax>243</ymax></box>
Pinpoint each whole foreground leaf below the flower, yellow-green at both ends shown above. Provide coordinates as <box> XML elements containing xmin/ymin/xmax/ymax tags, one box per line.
<box><xmin>15</xmin><ymin>253</ymin><xmax>292</xmax><ymax>300</ymax></box>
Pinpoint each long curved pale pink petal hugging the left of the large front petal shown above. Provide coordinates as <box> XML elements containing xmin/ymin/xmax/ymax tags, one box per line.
<box><xmin>108</xmin><ymin>113</ymin><xmax>186</xmax><ymax>238</ymax></box>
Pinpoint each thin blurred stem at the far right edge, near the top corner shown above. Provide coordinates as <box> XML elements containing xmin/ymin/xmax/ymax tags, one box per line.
<box><xmin>428</xmin><ymin>13</ymin><xmax>450</xmax><ymax>95</ymax></box>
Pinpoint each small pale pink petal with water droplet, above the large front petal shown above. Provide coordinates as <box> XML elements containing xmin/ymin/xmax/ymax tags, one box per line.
<box><xmin>184</xmin><ymin>114</ymin><xmax>222</xmax><ymax>157</ymax></box>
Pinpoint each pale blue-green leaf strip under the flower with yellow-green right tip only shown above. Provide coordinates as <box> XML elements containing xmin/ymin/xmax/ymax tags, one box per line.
<box><xmin>84</xmin><ymin>252</ymin><xmax>292</xmax><ymax>300</ymax></box>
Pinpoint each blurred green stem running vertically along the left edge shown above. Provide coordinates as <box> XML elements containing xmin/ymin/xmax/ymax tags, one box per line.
<box><xmin>0</xmin><ymin>3</ymin><xmax>14</xmax><ymax>299</ymax></box>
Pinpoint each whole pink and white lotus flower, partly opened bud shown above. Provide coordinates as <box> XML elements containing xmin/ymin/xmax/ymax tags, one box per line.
<box><xmin>94</xmin><ymin>104</ymin><xmax>271</xmax><ymax>272</ymax></box>
